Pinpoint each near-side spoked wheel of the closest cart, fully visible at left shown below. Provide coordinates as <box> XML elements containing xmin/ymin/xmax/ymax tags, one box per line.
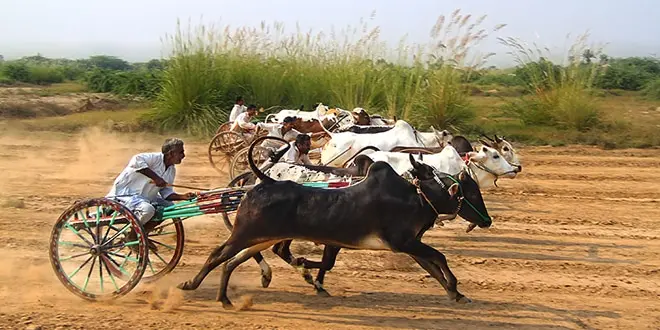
<box><xmin>49</xmin><ymin>198</ymin><xmax>149</xmax><ymax>301</ymax></box>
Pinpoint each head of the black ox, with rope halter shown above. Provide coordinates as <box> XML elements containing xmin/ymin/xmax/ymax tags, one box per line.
<box><xmin>408</xmin><ymin>154</ymin><xmax>493</xmax><ymax>232</ymax></box>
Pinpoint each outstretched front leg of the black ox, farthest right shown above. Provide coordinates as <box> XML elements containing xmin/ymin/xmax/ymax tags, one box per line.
<box><xmin>400</xmin><ymin>240</ymin><xmax>471</xmax><ymax>303</ymax></box>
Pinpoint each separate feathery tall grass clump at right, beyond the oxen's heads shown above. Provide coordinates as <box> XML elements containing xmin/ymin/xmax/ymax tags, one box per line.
<box><xmin>498</xmin><ymin>34</ymin><xmax>604</xmax><ymax>131</ymax></box>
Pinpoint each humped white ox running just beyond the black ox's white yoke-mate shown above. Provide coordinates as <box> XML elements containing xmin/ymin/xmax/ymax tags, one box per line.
<box><xmin>321</xmin><ymin>120</ymin><xmax>452</xmax><ymax>167</ymax></box>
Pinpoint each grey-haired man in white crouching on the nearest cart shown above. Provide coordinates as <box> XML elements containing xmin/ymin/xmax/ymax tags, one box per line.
<box><xmin>106</xmin><ymin>138</ymin><xmax>196</xmax><ymax>239</ymax></box>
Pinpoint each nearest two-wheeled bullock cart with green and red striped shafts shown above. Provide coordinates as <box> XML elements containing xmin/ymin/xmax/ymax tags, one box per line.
<box><xmin>49</xmin><ymin>171</ymin><xmax>360</xmax><ymax>301</ymax></box>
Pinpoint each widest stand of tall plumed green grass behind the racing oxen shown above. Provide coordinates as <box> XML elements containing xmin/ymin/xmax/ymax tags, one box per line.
<box><xmin>153</xmin><ymin>10</ymin><xmax>504</xmax><ymax>134</ymax></box>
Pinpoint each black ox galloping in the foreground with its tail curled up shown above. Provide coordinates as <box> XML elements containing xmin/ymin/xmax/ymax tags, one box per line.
<box><xmin>178</xmin><ymin>140</ymin><xmax>492</xmax><ymax>308</ymax></box>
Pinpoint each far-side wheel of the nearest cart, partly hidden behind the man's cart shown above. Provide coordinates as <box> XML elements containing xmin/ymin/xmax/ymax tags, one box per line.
<box><xmin>142</xmin><ymin>218</ymin><xmax>185</xmax><ymax>283</ymax></box>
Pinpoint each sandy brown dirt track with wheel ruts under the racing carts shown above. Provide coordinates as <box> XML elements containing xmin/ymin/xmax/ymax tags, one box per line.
<box><xmin>0</xmin><ymin>130</ymin><xmax>660</xmax><ymax>329</ymax></box>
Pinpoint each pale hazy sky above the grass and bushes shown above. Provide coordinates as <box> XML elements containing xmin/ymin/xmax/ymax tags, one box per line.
<box><xmin>0</xmin><ymin>0</ymin><xmax>660</xmax><ymax>65</ymax></box>
